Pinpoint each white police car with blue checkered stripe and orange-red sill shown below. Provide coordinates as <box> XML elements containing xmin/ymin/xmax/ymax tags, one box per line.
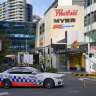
<box><xmin>0</xmin><ymin>67</ymin><xmax>64</xmax><ymax>88</ymax></box>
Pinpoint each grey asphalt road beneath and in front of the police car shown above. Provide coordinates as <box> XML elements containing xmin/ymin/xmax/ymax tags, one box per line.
<box><xmin>0</xmin><ymin>75</ymin><xmax>96</xmax><ymax>96</ymax></box>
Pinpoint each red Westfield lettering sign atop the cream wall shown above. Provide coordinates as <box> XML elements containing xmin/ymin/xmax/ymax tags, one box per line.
<box><xmin>55</xmin><ymin>9</ymin><xmax>78</xmax><ymax>16</ymax></box>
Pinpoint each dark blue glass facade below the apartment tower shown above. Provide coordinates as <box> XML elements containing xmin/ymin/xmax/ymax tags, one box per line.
<box><xmin>0</xmin><ymin>21</ymin><xmax>36</xmax><ymax>52</ymax></box>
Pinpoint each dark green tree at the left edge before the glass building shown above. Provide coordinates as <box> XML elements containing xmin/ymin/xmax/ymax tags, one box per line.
<box><xmin>0</xmin><ymin>31</ymin><xmax>9</xmax><ymax>65</ymax></box>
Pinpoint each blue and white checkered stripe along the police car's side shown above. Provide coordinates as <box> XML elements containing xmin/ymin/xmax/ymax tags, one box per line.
<box><xmin>10</xmin><ymin>76</ymin><xmax>43</xmax><ymax>84</ymax></box>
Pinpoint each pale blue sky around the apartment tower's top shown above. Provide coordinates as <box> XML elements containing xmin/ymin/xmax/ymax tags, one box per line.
<box><xmin>0</xmin><ymin>0</ymin><xmax>54</xmax><ymax>17</ymax></box>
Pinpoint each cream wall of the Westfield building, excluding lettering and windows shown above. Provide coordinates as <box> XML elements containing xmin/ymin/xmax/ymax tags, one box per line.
<box><xmin>36</xmin><ymin>5</ymin><xmax>84</xmax><ymax>47</ymax></box>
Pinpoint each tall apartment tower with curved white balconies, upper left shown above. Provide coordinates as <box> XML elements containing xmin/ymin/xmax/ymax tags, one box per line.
<box><xmin>0</xmin><ymin>0</ymin><xmax>32</xmax><ymax>22</ymax></box>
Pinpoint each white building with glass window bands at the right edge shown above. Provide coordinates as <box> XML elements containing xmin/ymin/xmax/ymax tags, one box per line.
<box><xmin>84</xmin><ymin>0</ymin><xmax>96</xmax><ymax>72</ymax></box>
